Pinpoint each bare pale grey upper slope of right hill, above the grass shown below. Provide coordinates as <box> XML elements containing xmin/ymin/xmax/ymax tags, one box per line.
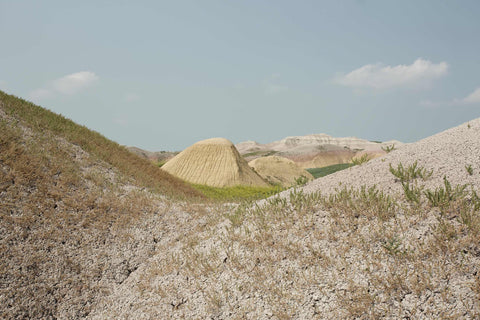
<box><xmin>304</xmin><ymin>118</ymin><xmax>480</xmax><ymax>194</ymax></box>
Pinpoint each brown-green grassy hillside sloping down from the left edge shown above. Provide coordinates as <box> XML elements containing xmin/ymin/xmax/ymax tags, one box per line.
<box><xmin>0</xmin><ymin>92</ymin><xmax>203</xmax><ymax>319</ymax></box>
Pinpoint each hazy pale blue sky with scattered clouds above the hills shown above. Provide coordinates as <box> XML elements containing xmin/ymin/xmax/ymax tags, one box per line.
<box><xmin>0</xmin><ymin>0</ymin><xmax>480</xmax><ymax>151</ymax></box>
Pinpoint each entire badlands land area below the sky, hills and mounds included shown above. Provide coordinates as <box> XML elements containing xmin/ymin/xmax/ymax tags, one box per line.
<box><xmin>0</xmin><ymin>92</ymin><xmax>480</xmax><ymax>319</ymax></box>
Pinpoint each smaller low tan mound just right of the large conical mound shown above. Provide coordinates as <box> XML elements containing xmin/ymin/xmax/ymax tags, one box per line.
<box><xmin>248</xmin><ymin>156</ymin><xmax>313</xmax><ymax>187</ymax></box>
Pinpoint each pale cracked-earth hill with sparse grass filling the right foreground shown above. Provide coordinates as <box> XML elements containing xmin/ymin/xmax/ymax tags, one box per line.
<box><xmin>89</xmin><ymin>119</ymin><xmax>480</xmax><ymax>319</ymax></box>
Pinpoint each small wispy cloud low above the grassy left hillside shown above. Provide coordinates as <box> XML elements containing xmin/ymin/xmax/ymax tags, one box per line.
<box><xmin>29</xmin><ymin>71</ymin><xmax>99</xmax><ymax>100</ymax></box>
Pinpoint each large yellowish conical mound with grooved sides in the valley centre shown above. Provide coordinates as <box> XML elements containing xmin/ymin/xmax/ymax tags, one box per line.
<box><xmin>162</xmin><ymin>138</ymin><xmax>268</xmax><ymax>187</ymax></box>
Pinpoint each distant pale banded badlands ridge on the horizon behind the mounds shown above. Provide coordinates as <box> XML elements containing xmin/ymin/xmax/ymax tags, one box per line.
<box><xmin>236</xmin><ymin>133</ymin><xmax>402</xmax><ymax>168</ymax></box>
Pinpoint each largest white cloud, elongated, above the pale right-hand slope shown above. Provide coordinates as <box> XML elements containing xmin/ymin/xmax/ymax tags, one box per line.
<box><xmin>334</xmin><ymin>58</ymin><xmax>448</xmax><ymax>89</ymax></box>
